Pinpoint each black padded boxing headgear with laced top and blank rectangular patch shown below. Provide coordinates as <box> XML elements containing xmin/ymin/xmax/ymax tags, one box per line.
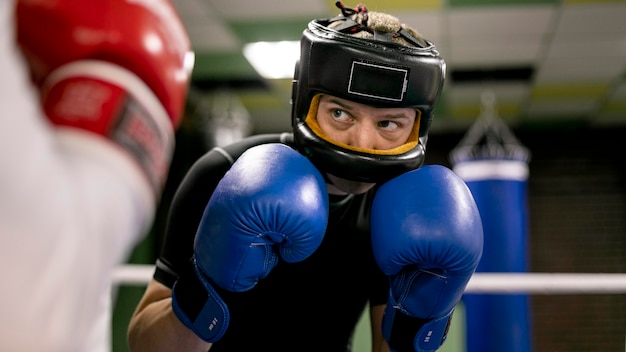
<box><xmin>291</xmin><ymin>2</ymin><xmax>446</xmax><ymax>182</ymax></box>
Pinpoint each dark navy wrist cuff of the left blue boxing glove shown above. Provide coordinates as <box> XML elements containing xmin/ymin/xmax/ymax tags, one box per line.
<box><xmin>172</xmin><ymin>259</ymin><xmax>230</xmax><ymax>343</ymax></box>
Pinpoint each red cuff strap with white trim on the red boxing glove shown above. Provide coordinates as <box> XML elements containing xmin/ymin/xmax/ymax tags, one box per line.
<box><xmin>42</xmin><ymin>60</ymin><xmax>174</xmax><ymax>194</ymax></box>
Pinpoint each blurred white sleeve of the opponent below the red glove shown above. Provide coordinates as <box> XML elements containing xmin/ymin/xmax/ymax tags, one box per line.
<box><xmin>0</xmin><ymin>0</ymin><xmax>156</xmax><ymax>352</ymax></box>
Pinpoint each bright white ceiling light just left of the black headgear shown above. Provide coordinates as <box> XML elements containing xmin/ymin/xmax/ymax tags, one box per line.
<box><xmin>243</xmin><ymin>41</ymin><xmax>300</xmax><ymax>79</ymax></box>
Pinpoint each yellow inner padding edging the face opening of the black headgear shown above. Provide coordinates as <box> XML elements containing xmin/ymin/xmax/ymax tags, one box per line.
<box><xmin>304</xmin><ymin>94</ymin><xmax>422</xmax><ymax>155</ymax></box>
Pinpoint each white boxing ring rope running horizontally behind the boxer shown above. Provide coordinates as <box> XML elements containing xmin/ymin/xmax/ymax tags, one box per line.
<box><xmin>112</xmin><ymin>264</ymin><xmax>626</xmax><ymax>295</ymax></box>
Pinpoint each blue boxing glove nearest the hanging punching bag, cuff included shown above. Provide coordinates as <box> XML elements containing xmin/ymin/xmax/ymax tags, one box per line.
<box><xmin>371</xmin><ymin>165</ymin><xmax>483</xmax><ymax>352</ymax></box>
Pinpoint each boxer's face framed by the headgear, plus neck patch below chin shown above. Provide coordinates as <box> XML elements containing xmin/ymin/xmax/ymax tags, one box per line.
<box><xmin>316</xmin><ymin>95</ymin><xmax>417</xmax><ymax>194</ymax></box>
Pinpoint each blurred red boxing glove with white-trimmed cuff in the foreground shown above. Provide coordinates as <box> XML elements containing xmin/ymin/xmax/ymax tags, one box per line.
<box><xmin>16</xmin><ymin>0</ymin><xmax>193</xmax><ymax>191</ymax></box>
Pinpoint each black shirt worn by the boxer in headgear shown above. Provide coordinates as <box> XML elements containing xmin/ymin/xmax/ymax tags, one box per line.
<box><xmin>154</xmin><ymin>134</ymin><xmax>389</xmax><ymax>352</ymax></box>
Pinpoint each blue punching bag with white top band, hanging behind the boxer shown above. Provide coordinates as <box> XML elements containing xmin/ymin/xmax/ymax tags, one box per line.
<box><xmin>451</xmin><ymin>95</ymin><xmax>532</xmax><ymax>352</ymax></box>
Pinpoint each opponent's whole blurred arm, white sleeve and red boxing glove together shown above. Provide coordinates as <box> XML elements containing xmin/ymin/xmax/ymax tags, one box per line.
<box><xmin>0</xmin><ymin>0</ymin><xmax>190</xmax><ymax>351</ymax></box>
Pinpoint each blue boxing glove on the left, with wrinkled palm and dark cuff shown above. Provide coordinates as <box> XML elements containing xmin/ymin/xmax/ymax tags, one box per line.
<box><xmin>172</xmin><ymin>144</ymin><xmax>328</xmax><ymax>342</ymax></box>
